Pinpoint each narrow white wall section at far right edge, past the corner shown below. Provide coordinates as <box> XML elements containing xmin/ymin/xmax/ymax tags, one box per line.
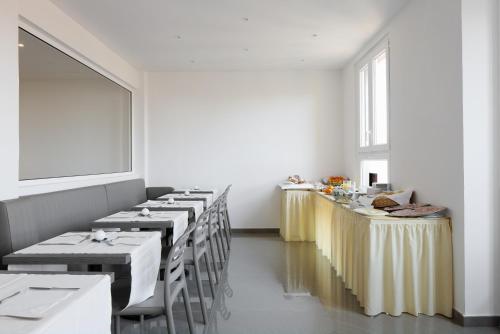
<box><xmin>462</xmin><ymin>0</ymin><xmax>500</xmax><ymax>315</ymax></box>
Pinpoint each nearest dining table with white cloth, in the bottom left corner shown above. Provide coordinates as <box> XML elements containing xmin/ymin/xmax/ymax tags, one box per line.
<box><xmin>0</xmin><ymin>273</ymin><xmax>112</xmax><ymax>334</ymax></box>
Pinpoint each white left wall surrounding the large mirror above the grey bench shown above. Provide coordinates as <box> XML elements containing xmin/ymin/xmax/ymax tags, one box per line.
<box><xmin>0</xmin><ymin>0</ymin><xmax>144</xmax><ymax>200</ymax></box>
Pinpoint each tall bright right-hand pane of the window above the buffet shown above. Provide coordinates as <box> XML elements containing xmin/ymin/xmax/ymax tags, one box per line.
<box><xmin>373</xmin><ymin>51</ymin><xmax>387</xmax><ymax>145</ymax></box>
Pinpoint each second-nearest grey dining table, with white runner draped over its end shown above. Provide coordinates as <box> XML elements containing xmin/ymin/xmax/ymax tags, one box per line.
<box><xmin>3</xmin><ymin>231</ymin><xmax>161</xmax><ymax>306</ymax></box>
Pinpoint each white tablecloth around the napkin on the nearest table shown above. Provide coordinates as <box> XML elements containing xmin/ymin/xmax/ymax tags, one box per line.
<box><xmin>0</xmin><ymin>274</ymin><xmax>111</xmax><ymax>334</ymax></box>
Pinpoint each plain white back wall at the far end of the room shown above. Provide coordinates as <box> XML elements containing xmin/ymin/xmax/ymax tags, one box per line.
<box><xmin>147</xmin><ymin>71</ymin><xmax>343</xmax><ymax>228</ymax></box>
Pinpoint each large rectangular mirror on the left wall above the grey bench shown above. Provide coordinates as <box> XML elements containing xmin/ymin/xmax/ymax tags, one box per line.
<box><xmin>19</xmin><ymin>28</ymin><xmax>132</xmax><ymax>180</ymax></box>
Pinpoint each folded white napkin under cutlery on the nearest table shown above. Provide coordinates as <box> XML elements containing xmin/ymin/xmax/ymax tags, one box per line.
<box><xmin>0</xmin><ymin>288</ymin><xmax>76</xmax><ymax>319</ymax></box>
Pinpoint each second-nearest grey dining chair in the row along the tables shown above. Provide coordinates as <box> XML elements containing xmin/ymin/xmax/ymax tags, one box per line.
<box><xmin>184</xmin><ymin>205</ymin><xmax>216</xmax><ymax>324</ymax></box>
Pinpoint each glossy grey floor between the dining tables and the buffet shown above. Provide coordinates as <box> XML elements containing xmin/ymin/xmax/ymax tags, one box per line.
<box><xmin>122</xmin><ymin>236</ymin><xmax>500</xmax><ymax>334</ymax></box>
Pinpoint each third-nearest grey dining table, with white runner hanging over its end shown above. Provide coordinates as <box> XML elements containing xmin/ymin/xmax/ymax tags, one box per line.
<box><xmin>90</xmin><ymin>208</ymin><xmax>189</xmax><ymax>242</ymax></box>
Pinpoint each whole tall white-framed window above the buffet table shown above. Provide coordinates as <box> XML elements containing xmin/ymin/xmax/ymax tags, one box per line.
<box><xmin>357</xmin><ymin>39</ymin><xmax>389</xmax><ymax>187</ymax></box>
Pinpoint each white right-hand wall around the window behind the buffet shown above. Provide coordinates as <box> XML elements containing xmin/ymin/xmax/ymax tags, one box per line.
<box><xmin>343</xmin><ymin>0</ymin><xmax>465</xmax><ymax>312</ymax></box>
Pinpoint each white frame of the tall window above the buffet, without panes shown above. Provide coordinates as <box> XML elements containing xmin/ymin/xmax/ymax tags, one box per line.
<box><xmin>354</xmin><ymin>36</ymin><xmax>391</xmax><ymax>186</ymax></box>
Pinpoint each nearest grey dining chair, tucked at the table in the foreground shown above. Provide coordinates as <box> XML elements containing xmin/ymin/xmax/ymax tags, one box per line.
<box><xmin>113</xmin><ymin>223</ymin><xmax>196</xmax><ymax>334</ymax></box>
